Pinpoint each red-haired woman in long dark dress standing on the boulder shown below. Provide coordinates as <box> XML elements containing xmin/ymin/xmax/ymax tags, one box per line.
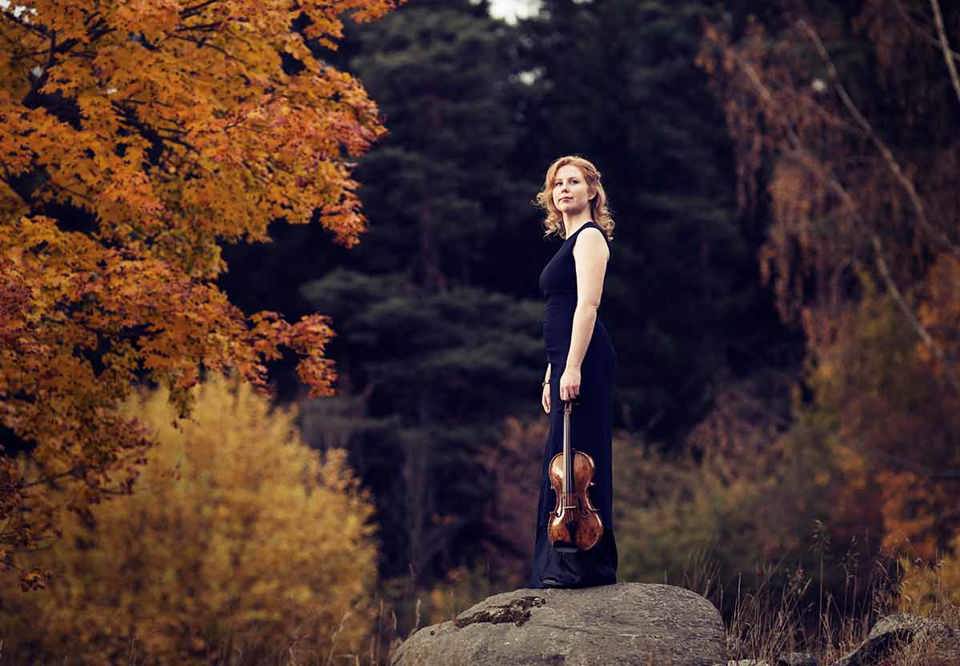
<box><xmin>529</xmin><ymin>155</ymin><xmax>617</xmax><ymax>588</ymax></box>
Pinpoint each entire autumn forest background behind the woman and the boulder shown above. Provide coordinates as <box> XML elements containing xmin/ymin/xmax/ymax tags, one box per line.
<box><xmin>0</xmin><ymin>0</ymin><xmax>960</xmax><ymax>660</ymax></box>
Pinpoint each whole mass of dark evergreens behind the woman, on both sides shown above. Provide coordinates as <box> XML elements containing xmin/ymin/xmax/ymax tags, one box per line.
<box><xmin>218</xmin><ymin>0</ymin><xmax>804</xmax><ymax>608</ymax></box>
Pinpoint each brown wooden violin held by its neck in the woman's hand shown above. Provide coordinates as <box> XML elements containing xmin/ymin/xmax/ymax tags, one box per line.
<box><xmin>547</xmin><ymin>400</ymin><xmax>603</xmax><ymax>553</ymax></box>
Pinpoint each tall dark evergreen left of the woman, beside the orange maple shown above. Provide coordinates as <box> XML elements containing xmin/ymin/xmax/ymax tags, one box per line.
<box><xmin>302</xmin><ymin>1</ymin><xmax>551</xmax><ymax>584</ymax></box>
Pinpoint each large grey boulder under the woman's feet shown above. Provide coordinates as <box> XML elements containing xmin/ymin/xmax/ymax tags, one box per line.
<box><xmin>391</xmin><ymin>583</ymin><xmax>726</xmax><ymax>666</ymax></box>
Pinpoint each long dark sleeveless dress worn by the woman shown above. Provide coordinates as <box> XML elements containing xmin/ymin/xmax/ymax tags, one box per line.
<box><xmin>529</xmin><ymin>221</ymin><xmax>617</xmax><ymax>588</ymax></box>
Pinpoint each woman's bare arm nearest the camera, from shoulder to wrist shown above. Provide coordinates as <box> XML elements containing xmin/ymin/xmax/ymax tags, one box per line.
<box><xmin>566</xmin><ymin>227</ymin><xmax>610</xmax><ymax>374</ymax></box>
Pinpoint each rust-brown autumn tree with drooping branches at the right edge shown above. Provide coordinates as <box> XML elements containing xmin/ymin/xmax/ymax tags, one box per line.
<box><xmin>701</xmin><ymin>0</ymin><xmax>960</xmax><ymax>560</ymax></box>
